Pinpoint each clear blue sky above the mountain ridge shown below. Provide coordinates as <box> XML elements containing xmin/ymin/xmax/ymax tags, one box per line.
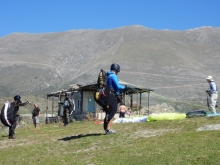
<box><xmin>0</xmin><ymin>0</ymin><xmax>220</xmax><ymax>37</ymax></box>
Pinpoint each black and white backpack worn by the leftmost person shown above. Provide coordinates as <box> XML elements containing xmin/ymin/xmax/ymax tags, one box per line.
<box><xmin>1</xmin><ymin>101</ymin><xmax>15</xmax><ymax>127</ymax></box>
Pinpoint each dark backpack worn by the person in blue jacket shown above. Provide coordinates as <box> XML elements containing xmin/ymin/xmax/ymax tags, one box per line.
<box><xmin>94</xmin><ymin>69</ymin><xmax>108</xmax><ymax>111</ymax></box>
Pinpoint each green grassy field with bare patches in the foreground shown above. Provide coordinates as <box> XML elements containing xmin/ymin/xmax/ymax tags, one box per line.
<box><xmin>0</xmin><ymin>117</ymin><xmax>220</xmax><ymax>165</ymax></box>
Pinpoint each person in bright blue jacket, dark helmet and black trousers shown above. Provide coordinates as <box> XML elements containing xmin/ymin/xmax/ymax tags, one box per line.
<box><xmin>104</xmin><ymin>63</ymin><xmax>127</xmax><ymax>134</ymax></box>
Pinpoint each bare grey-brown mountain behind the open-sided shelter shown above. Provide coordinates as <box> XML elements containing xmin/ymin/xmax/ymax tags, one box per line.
<box><xmin>0</xmin><ymin>26</ymin><xmax>220</xmax><ymax>111</ymax></box>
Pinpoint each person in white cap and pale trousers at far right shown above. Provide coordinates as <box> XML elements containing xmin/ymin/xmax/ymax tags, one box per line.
<box><xmin>206</xmin><ymin>76</ymin><xmax>218</xmax><ymax>114</ymax></box>
